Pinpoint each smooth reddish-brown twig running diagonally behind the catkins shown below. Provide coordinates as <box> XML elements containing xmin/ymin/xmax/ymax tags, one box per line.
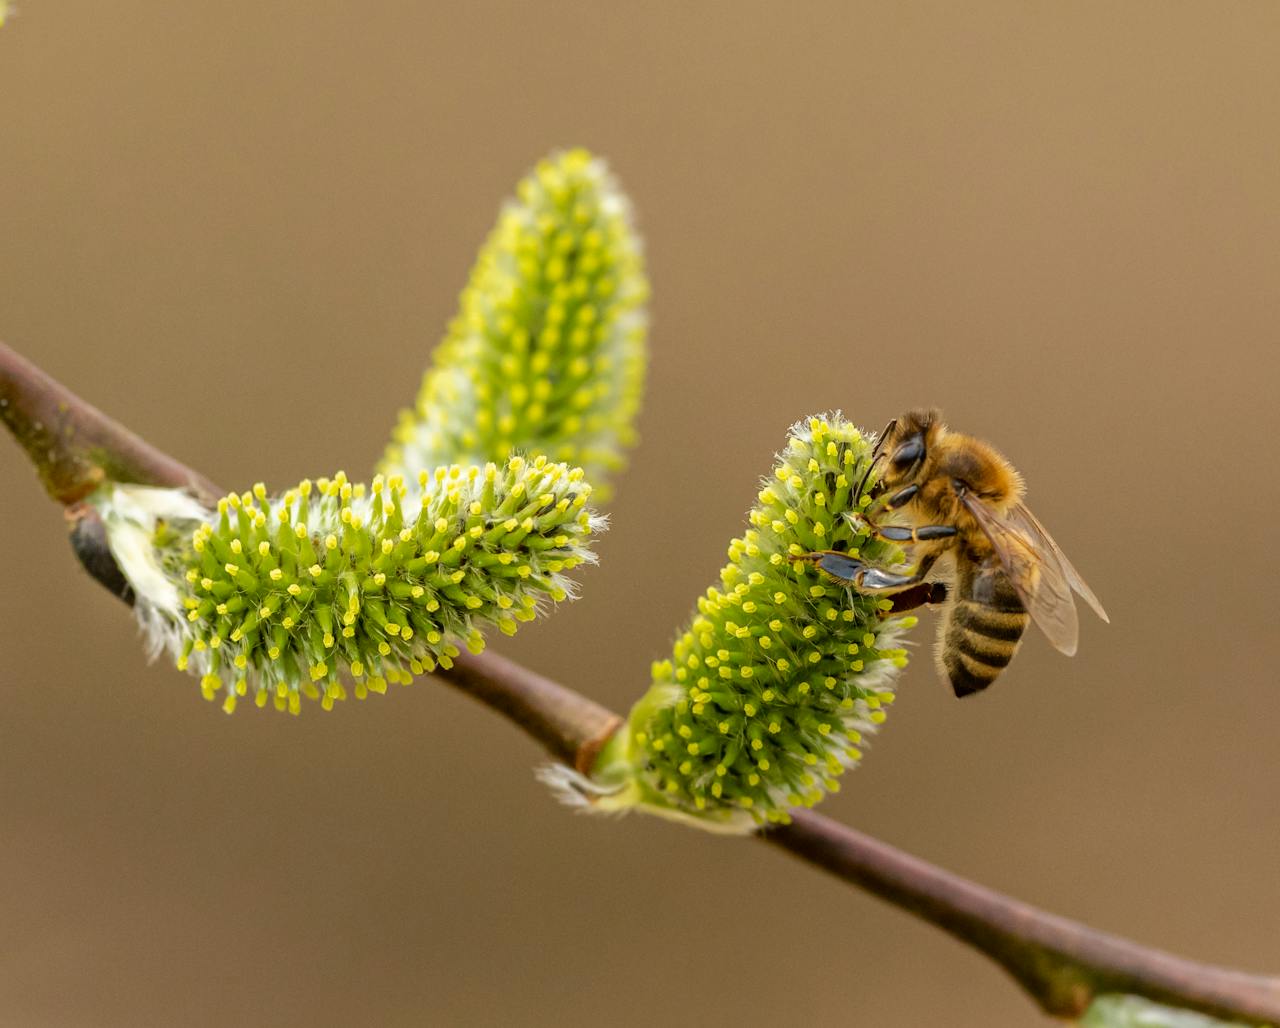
<box><xmin>0</xmin><ymin>344</ymin><xmax>1280</xmax><ymax>1024</ymax></box>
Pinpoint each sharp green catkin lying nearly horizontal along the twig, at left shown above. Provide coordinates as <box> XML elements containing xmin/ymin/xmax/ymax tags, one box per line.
<box><xmin>105</xmin><ymin>457</ymin><xmax>602</xmax><ymax>713</ymax></box>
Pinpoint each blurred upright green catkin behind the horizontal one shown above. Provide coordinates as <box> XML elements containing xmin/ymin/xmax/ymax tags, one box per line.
<box><xmin>379</xmin><ymin>150</ymin><xmax>649</xmax><ymax>499</ymax></box>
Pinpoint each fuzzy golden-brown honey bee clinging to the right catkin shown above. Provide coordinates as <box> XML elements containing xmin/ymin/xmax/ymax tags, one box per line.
<box><xmin>791</xmin><ymin>411</ymin><xmax>1110</xmax><ymax>696</ymax></box>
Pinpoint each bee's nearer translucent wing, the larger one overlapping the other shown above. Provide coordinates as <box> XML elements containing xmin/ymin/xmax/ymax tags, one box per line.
<box><xmin>961</xmin><ymin>494</ymin><xmax>1079</xmax><ymax>657</ymax></box>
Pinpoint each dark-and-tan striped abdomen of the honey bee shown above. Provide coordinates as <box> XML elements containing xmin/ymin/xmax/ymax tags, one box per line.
<box><xmin>938</xmin><ymin>559</ymin><xmax>1030</xmax><ymax>696</ymax></box>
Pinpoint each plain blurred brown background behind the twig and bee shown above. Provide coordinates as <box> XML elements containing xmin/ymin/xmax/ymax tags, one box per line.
<box><xmin>0</xmin><ymin>0</ymin><xmax>1280</xmax><ymax>1028</ymax></box>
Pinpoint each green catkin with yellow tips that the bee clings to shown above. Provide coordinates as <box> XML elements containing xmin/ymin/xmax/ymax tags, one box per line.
<box><xmin>549</xmin><ymin>416</ymin><xmax>915</xmax><ymax>831</ymax></box>
